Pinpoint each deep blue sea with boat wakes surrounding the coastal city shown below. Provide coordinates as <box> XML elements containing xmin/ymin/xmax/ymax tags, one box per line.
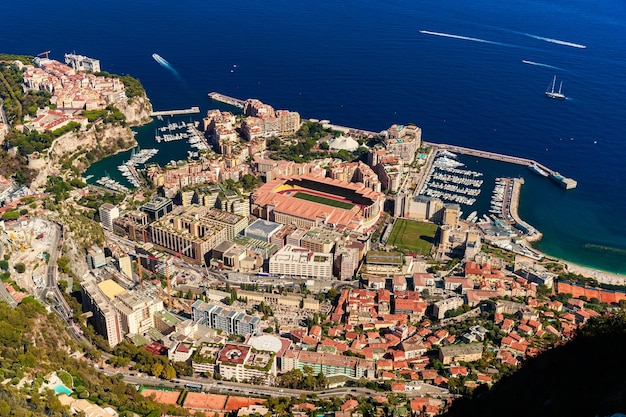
<box><xmin>0</xmin><ymin>0</ymin><xmax>626</xmax><ymax>273</ymax></box>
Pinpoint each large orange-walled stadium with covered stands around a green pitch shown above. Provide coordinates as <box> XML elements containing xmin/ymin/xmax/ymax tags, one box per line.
<box><xmin>251</xmin><ymin>175</ymin><xmax>385</xmax><ymax>232</ymax></box>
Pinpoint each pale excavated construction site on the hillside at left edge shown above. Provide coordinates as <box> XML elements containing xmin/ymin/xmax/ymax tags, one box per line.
<box><xmin>0</xmin><ymin>219</ymin><xmax>57</xmax><ymax>295</ymax></box>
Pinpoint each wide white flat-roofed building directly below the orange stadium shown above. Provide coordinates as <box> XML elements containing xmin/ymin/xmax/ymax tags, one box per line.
<box><xmin>269</xmin><ymin>245</ymin><xmax>333</xmax><ymax>279</ymax></box>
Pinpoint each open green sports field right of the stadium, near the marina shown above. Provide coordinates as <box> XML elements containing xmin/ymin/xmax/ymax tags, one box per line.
<box><xmin>387</xmin><ymin>219</ymin><xmax>437</xmax><ymax>256</ymax></box>
